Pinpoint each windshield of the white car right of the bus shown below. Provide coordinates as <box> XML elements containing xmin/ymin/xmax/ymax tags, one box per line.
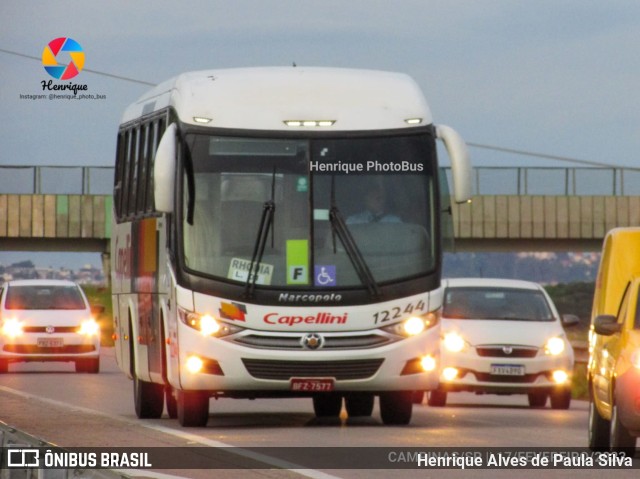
<box><xmin>442</xmin><ymin>287</ymin><xmax>553</xmax><ymax>321</ymax></box>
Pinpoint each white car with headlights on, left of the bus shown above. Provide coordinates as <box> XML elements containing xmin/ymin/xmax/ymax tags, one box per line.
<box><xmin>0</xmin><ymin>280</ymin><xmax>104</xmax><ymax>373</ymax></box>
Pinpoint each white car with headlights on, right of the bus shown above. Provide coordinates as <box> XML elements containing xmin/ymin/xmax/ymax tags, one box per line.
<box><xmin>428</xmin><ymin>278</ymin><xmax>578</xmax><ymax>409</ymax></box>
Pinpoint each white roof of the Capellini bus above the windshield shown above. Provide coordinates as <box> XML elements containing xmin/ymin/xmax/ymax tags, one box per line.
<box><xmin>122</xmin><ymin>67</ymin><xmax>433</xmax><ymax>131</ymax></box>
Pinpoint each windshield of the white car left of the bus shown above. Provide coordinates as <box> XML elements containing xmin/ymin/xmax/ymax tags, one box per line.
<box><xmin>4</xmin><ymin>285</ymin><xmax>86</xmax><ymax>310</ymax></box>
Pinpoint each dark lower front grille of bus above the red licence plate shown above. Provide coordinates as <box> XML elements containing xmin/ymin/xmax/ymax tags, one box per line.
<box><xmin>242</xmin><ymin>358</ymin><xmax>384</xmax><ymax>381</ymax></box>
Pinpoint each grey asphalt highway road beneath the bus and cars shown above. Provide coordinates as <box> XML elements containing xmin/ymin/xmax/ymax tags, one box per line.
<box><xmin>0</xmin><ymin>349</ymin><xmax>638</xmax><ymax>479</ymax></box>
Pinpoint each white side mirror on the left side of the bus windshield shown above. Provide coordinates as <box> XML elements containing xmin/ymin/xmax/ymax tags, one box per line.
<box><xmin>158</xmin><ymin>123</ymin><xmax>178</xmax><ymax>213</ymax></box>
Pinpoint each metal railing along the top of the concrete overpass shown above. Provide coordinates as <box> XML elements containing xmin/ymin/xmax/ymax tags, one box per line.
<box><xmin>0</xmin><ymin>165</ymin><xmax>640</xmax><ymax>196</ymax></box>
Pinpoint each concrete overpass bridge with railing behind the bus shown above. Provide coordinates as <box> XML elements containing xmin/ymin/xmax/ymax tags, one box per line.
<box><xmin>0</xmin><ymin>166</ymin><xmax>640</xmax><ymax>260</ymax></box>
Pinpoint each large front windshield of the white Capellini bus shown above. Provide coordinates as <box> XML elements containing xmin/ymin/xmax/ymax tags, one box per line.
<box><xmin>182</xmin><ymin>133</ymin><xmax>438</xmax><ymax>289</ymax></box>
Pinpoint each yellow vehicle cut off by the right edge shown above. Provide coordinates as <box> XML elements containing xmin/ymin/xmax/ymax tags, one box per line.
<box><xmin>587</xmin><ymin>228</ymin><xmax>640</xmax><ymax>454</ymax></box>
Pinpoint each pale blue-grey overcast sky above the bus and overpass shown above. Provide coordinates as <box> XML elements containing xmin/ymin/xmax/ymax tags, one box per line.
<box><xmin>0</xmin><ymin>0</ymin><xmax>640</xmax><ymax>270</ymax></box>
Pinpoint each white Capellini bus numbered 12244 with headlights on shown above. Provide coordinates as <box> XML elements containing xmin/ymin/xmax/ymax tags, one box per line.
<box><xmin>112</xmin><ymin>67</ymin><xmax>471</xmax><ymax>426</ymax></box>
